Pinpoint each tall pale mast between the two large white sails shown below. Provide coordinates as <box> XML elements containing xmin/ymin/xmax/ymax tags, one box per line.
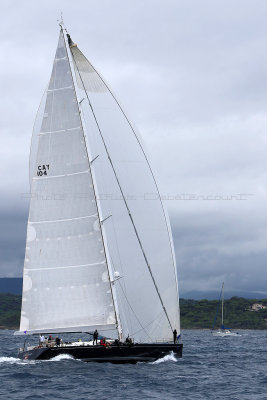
<box><xmin>59</xmin><ymin>21</ymin><xmax>123</xmax><ymax>340</ymax></box>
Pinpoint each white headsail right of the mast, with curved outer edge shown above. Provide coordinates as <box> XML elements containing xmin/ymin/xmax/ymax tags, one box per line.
<box><xmin>67</xmin><ymin>33</ymin><xmax>180</xmax><ymax>342</ymax></box>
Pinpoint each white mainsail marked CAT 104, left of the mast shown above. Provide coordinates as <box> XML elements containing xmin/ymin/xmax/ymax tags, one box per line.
<box><xmin>16</xmin><ymin>31</ymin><xmax>117</xmax><ymax>336</ymax></box>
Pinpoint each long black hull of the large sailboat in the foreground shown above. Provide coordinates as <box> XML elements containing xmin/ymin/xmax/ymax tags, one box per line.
<box><xmin>18</xmin><ymin>343</ymin><xmax>183</xmax><ymax>364</ymax></box>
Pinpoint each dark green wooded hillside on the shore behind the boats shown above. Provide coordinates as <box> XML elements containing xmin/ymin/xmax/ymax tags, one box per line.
<box><xmin>0</xmin><ymin>293</ymin><xmax>267</xmax><ymax>329</ymax></box>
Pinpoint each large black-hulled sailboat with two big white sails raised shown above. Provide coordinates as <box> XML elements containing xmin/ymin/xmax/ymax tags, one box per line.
<box><xmin>15</xmin><ymin>22</ymin><xmax>183</xmax><ymax>363</ymax></box>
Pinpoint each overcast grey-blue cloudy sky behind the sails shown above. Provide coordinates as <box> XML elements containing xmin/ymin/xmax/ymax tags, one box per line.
<box><xmin>0</xmin><ymin>0</ymin><xmax>267</xmax><ymax>295</ymax></box>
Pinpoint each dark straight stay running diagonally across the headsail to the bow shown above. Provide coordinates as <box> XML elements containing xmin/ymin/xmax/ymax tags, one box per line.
<box><xmin>71</xmin><ymin>45</ymin><xmax>173</xmax><ymax>331</ymax></box>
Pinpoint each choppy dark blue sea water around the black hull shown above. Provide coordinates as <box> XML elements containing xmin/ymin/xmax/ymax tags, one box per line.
<box><xmin>0</xmin><ymin>330</ymin><xmax>267</xmax><ymax>400</ymax></box>
